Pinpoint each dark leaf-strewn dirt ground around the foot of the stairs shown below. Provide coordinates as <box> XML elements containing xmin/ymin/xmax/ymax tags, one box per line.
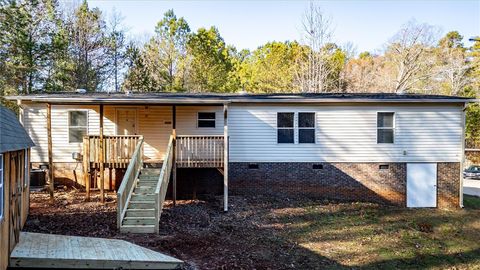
<box><xmin>24</xmin><ymin>190</ymin><xmax>333</xmax><ymax>269</ymax></box>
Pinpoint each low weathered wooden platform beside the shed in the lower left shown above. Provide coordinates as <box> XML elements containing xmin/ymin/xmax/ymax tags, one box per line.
<box><xmin>9</xmin><ymin>232</ymin><xmax>182</xmax><ymax>269</ymax></box>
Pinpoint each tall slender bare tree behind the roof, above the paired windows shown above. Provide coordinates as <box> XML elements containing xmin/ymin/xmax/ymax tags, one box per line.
<box><xmin>296</xmin><ymin>3</ymin><xmax>332</xmax><ymax>92</ymax></box>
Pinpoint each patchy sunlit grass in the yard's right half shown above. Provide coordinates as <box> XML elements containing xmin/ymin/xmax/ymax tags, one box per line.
<box><xmin>272</xmin><ymin>196</ymin><xmax>480</xmax><ymax>269</ymax></box>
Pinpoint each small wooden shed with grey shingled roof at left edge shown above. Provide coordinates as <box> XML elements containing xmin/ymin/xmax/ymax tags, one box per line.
<box><xmin>0</xmin><ymin>106</ymin><xmax>34</xmax><ymax>270</ymax></box>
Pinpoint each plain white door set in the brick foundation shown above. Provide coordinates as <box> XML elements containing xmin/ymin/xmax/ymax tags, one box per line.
<box><xmin>407</xmin><ymin>163</ymin><xmax>437</xmax><ymax>207</ymax></box>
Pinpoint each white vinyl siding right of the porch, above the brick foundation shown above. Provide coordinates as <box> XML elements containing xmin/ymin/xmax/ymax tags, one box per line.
<box><xmin>228</xmin><ymin>104</ymin><xmax>462</xmax><ymax>162</ymax></box>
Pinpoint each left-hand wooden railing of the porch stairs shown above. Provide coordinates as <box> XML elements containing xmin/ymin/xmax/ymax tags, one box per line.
<box><xmin>117</xmin><ymin>137</ymin><xmax>143</xmax><ymax>229</ymax></box>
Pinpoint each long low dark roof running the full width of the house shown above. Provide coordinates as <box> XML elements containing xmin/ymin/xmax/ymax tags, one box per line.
<box><xmin>6</xmin><ymin>92</ymin><xmax>474</xmax><ymax>105</ymax></box>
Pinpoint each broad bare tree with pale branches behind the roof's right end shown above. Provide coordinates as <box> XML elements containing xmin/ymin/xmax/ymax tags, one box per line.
<box><xmin>385</xmin><ymin>20</ymin><xmax>436</xmax><ymax>93</ymax></box>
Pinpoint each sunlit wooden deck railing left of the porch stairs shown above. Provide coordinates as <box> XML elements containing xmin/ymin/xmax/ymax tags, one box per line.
<box><xmin>83</xmin><ymin>135</ymin><xmax>143</xmax><ymax>168</ymax></box>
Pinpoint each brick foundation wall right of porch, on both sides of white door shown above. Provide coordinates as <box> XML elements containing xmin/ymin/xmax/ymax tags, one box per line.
<box><xmin>229</xmin><ymin>162</ymin><xmax>460</xmax><ymax>208</ymax></box>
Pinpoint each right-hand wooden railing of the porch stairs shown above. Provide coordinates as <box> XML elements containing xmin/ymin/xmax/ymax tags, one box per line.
<box><xmin>155</xmin><ymin>135</ymin><xmax>174</xmax><ymax>234</ymax></box>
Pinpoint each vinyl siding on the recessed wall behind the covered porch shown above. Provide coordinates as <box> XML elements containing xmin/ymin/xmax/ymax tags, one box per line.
<box><xmin>23</xmin><ymin>103</ymin><xmax>223</xmax><ymax>162</ymax></box>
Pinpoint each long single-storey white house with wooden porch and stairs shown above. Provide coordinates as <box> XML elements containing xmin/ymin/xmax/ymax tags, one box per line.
<box><xmin>9</xmin><ymin>93</ymin><xmax>470</xmax><ymax>232</ymax></box>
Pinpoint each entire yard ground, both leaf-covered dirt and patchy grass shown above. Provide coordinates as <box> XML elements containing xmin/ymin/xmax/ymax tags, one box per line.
<box><xmin>25</xmin><ymin>191</ymin><xmax>480</xmax><ymax>269</ymax></box>
